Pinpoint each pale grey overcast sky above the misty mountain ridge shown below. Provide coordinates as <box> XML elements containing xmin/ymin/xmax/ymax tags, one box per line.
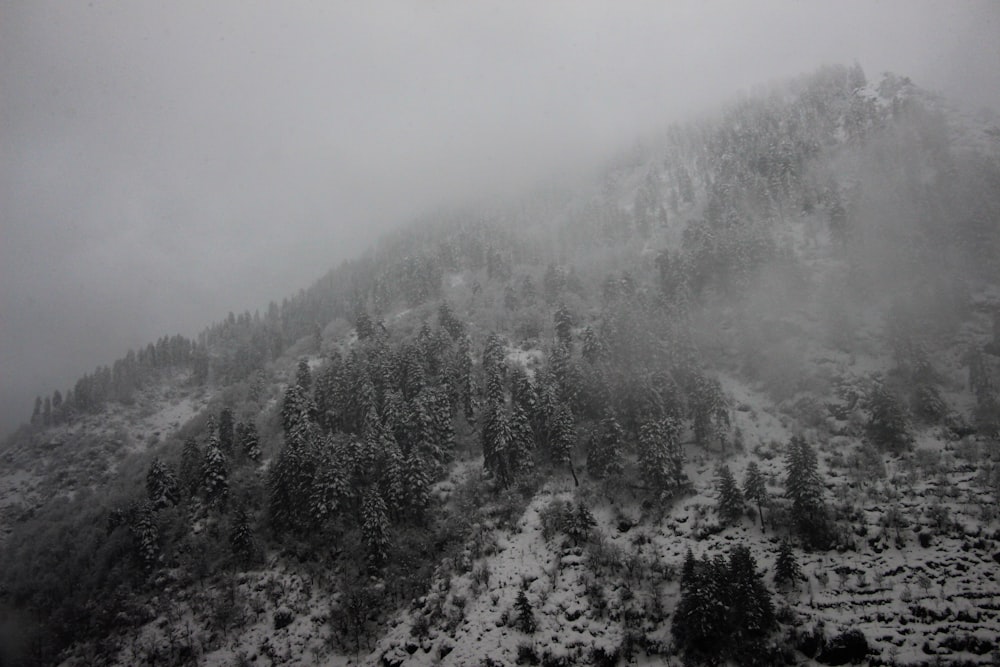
<box><xmin>0</xmin><ymin>0</ymin><xmax>1000</xmax><ymax>431</ymax></box>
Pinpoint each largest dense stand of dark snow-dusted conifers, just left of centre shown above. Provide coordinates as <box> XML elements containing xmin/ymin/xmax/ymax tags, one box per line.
<box><xmin>269</xmin><ymin>318</ymin><xmax>466</xmax><ymax>566</ymax></box>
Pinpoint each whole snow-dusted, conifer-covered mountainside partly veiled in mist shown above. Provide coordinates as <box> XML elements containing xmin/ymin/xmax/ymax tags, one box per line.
<box><xmin>0</xmin><ymin>66</ymin><xmax>1000</xmax><ymax>665</ymax></box>
